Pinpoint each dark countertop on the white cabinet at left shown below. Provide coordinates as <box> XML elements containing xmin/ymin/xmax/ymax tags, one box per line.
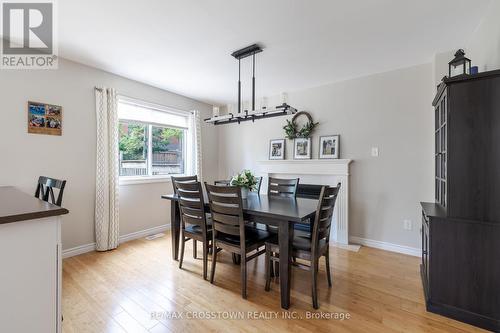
<box><xmin>0</xmin><ymin>186</ymin><xmax>69</xmax><ymax>224</ymax></box>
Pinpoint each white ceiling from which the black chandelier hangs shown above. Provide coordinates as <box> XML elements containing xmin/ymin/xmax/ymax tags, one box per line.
<box><xmin>58</xmin><ymin>0</ymin><xmax>490</xmax><ymax>103</ymax></box>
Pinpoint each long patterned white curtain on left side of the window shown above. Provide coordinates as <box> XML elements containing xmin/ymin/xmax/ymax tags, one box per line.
<box><xmin>95</xmin><ymin>87</ymin><xmax>119</xmax><ymax>251</ymax></box>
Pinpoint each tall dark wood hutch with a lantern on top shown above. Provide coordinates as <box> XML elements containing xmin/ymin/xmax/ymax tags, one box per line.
<box><xmin>421</xmin><ymin>71</ymin><xmax>500</xmax><ymax>332</ymax></box>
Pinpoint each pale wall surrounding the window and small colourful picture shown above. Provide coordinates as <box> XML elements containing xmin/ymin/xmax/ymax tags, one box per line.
<box><xmin>0</xmin><ymin>59</ymin><xmax>218</xmax><ymax>249</ymax></box>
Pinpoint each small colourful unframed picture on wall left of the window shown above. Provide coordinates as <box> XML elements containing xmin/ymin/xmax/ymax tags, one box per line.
<box><xmin>28</xmin><ymin>102</ymin><xmax>62</xmax><ymax>135</ymax></box>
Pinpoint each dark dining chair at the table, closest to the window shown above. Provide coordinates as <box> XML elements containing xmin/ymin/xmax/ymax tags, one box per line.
<box><xmin>174</xmin><ymin>181</ymin><xmax>212</xmax><ymax>280</ymax></box>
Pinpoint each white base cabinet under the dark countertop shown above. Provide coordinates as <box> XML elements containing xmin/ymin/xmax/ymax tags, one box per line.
<box><xmin>0</xmin><ymin>216</ymin><xmax>62</xmax><ymax>333</ymax></box>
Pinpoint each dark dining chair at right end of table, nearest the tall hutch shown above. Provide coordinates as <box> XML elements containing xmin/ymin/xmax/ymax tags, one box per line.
<box><xmin>265</xmin><ymin>183</ymin><xmax>340</xmax><ymax>309</ymax></box>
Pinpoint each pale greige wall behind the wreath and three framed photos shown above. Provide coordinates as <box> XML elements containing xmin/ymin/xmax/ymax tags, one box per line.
<box><xmin>218</xmin><ymin>64</ymin><xmax>434</xmax><ymax>247</ymax></box>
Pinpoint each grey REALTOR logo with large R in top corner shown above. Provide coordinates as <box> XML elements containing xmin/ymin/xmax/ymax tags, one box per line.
<box><xmin>0</xmin><ymin>0</ymin><xmax>57</xmax><ymax>69</ymax></box>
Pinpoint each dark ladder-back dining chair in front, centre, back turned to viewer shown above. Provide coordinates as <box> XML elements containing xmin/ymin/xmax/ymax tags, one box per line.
<box><xmin>205</xmin><ymin>183</ymin><xmax>271</xmax><ymax>299</ymax></box>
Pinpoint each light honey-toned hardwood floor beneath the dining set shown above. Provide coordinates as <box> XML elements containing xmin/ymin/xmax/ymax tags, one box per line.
<box><xmin>62</xmin><ymin>234</ymin><xmax>488</xmax><ymax>333</ymax></box>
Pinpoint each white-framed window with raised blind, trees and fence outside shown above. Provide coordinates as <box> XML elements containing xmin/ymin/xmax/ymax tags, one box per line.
<box><xmin>118</xmin><ymin>98</ymin><xmax>191</xmax><ymax>179</ymax></box>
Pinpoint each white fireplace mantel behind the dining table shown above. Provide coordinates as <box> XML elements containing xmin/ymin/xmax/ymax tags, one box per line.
<box><xmin>257</xmin><ymin>159</ymin><xmax>353</xmax><ymax>245</ymax></box>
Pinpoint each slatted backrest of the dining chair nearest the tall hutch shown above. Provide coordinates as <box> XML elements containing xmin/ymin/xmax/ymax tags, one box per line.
<box><xmin>311</xmin><ymin>183</ymin><xmax>340</xmax><ymax>252</ymax></box>
